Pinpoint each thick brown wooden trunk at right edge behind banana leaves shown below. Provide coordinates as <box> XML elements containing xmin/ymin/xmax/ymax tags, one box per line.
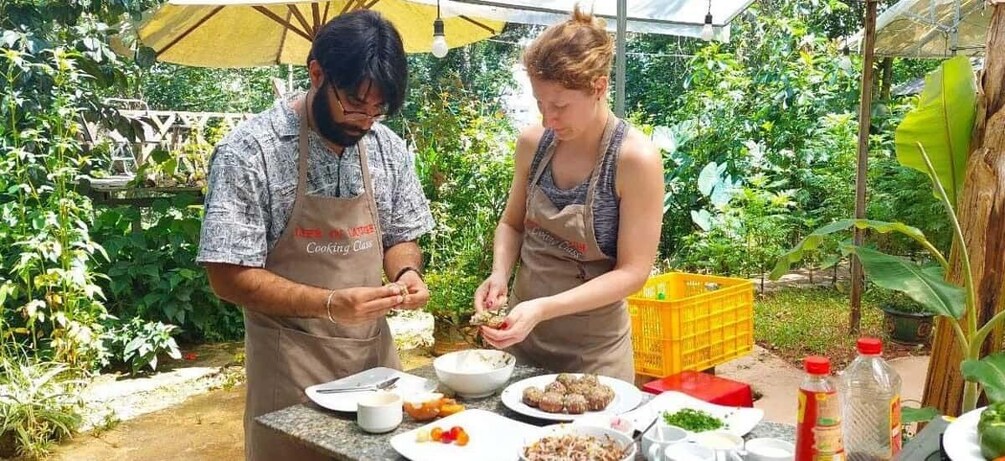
<box><xmin>922</xmin><ymin>0</ymin><xmax>1005</xmax><ymax>415</ymax></box>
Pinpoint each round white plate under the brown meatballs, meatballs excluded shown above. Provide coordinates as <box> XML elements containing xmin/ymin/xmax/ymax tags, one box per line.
<box><xmin>500</xmin><ymin>373</ymin><xmax>642</xmax><ymax>421</ymax></box>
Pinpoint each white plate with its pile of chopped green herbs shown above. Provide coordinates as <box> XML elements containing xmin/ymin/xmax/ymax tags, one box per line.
<box><xmin>621</xmin><ymin>391</ymin><xmax>764</xmax><ymax>437</ymax></box>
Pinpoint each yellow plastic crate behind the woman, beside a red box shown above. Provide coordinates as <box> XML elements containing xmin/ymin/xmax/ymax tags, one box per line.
<box><xmin>628</xmin><ymin>272</ymin><xmax>754</xmax><ymax>378</ymax></box>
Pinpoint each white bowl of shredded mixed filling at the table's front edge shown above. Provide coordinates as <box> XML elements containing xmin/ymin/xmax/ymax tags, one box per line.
<box><xmin>520</xmin><ymin>424</ymin><xmax>636</xmax><ymax>461</ymax></box>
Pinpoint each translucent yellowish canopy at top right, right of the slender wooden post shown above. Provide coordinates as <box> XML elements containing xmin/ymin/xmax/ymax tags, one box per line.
<box><xmin>851</xmin><ymin>0</ymin><xmax>992</xmax><ymax>58</ymax></box>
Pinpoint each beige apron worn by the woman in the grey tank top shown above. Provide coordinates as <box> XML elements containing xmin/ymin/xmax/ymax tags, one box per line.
<box><xmin>510</xmin><ymin>114</ymin><xmax>635</xmax><ymax>383</ymax></box>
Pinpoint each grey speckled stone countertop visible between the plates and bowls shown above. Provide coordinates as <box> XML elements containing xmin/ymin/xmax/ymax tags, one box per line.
<box><xmin>255</xmin><ymin>365</ymin><xmax>795</xmax><ymax>461</ymax></box>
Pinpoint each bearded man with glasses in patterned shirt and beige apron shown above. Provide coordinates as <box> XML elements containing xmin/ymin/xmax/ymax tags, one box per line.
<box><xmin>197</xmin><ymin>11</ymin><xmax>433</xmax><ymax>460</ymax></box>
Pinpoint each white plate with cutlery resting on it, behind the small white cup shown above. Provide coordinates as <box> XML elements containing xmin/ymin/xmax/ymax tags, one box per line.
<box><xmin>304</xmin><ymin>367</ymin><xmax>436</xmax><ymax>412</ymax></box>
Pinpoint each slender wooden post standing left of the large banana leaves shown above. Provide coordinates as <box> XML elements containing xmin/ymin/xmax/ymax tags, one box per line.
<box><xmin>848</xmin><ymin>0</ymin><xmax>876</xmax><ymax>334</ymax></box>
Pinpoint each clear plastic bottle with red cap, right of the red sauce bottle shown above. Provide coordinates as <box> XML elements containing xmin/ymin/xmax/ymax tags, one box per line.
<box><xmin>841</xmin><ymin>337</ymin><xmax>901</xmax><ymax>461</ymax></box>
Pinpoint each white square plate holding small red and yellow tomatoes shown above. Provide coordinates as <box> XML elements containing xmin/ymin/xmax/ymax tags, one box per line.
<box><xmin>391</xmin><ymin>409</ymin><xmax>541</xmax><ymax>461</ymax></box>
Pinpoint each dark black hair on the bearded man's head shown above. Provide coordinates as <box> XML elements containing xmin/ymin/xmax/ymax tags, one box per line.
<box><xmin>308</xmin><ymin>10</ymin><xmax>408</xmax><ymax>114</ymax></box>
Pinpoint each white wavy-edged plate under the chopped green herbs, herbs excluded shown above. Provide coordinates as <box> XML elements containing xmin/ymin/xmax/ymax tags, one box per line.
<box><xmin>622</xmin><ymin>391</ymin><xmax>764</xmax><ymax>437</ymax></box>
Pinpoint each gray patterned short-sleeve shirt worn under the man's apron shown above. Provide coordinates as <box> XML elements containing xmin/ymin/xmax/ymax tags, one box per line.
<box><xmin>196</xmin><ymin>94</ymin><xmax>433</xmax><ymax>267</ymax></box>
